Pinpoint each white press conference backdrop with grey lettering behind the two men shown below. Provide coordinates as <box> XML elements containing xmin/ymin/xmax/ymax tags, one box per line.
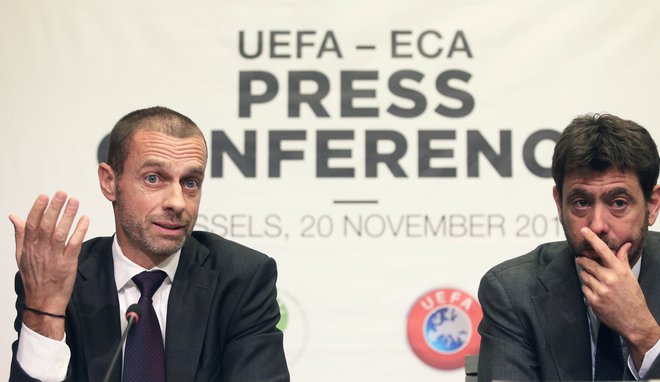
<box><xmin>0</xmin><ymin>0</ymin><xmax>660</xmax><ymax>381</ymax></box>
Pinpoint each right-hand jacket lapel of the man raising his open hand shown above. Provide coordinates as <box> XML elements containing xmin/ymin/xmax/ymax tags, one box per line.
<box><xmin>165</xmin><ymin>237</ymin><xmax>218</xmax><ymax>381</ymax></box>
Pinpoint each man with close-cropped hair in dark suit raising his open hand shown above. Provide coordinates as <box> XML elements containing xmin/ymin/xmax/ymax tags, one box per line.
<box><xmin>10</xmin><ymin>107</ymin><xmax>289</xmax><ymax>382</ymax></box>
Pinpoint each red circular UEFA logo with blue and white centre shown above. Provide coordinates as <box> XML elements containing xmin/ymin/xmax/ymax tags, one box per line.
<box><xmin>407</xmin><ymin>289</ymin><xmax>483</xmax><ymax>370</ymax></box>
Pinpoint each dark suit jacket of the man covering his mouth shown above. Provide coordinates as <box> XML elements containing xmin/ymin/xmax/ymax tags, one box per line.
<box><xmin>478</xmin><ymin>232</ymin><xmax>660</xmax><ymax>381</ymax></box>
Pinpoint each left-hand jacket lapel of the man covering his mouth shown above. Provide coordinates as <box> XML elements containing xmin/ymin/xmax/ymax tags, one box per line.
<box><xmin>533</xmin><ymin>249</ymin><xmax>592</xmax><ymax>380</ymax></box>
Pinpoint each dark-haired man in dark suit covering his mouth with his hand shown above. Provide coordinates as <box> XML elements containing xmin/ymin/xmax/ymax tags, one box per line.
<box><xmin>478</xmin><ymin>115</ymin><xmax>660</xmax><ymax>381</ymax></box>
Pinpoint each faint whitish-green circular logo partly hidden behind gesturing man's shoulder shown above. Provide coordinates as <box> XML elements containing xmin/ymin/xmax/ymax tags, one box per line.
<box><xmin>277</xmin><ymin>289</ymin><xmax>308</xmax><ymax>365</ymax></box>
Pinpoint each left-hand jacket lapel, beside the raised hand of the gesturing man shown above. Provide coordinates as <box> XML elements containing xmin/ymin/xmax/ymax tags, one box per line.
<box><xmin>72</xmin><ymin>238</ymin><xmax>121</xmax><ymax>381</ymax></box>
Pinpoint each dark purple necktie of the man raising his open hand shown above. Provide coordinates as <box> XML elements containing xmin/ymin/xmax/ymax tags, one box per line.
<box><xmin>124</xmin><ymin>271</ymin><xmax>167</xmax><ymax>382</ymax></box>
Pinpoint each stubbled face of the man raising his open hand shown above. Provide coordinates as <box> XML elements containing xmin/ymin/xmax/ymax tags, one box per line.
<box><xmin>115</xmin><ymin>130</ymin><xmax>206</xmax><ymax>266</ymax></box>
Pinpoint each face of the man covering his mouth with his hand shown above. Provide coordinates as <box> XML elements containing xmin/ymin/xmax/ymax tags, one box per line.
<box><xmin>553</xmin><ymin>169</ymin><xmax>655</xmax><ymax>264</ymax></box>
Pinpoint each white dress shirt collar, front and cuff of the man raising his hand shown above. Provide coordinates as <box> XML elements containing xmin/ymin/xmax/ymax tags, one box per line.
<box><xmin>16</xmin><ymin>235</ymin><xmax>181</xmax><ymax>382</ymax></box>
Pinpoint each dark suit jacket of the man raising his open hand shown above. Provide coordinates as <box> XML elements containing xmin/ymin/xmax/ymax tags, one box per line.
<box><xmin>10</xmin><ymin>232</ymin><xmax>289</xmax><ymax>382</ymax></box>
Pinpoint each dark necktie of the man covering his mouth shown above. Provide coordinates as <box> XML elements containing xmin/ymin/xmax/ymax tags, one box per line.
<box><xmin>594</xmin><ymin>322</ymin><xmax>623</xmax><ymax>381</ymax></box>
